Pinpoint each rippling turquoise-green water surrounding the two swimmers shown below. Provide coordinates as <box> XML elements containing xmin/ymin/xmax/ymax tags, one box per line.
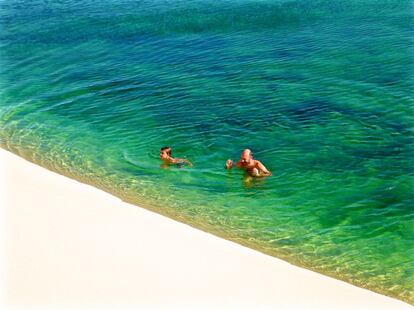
<box><xmin>0</xmin><ymin>0</ymin><xmax>414</xmax><ymax>303</ymax></box>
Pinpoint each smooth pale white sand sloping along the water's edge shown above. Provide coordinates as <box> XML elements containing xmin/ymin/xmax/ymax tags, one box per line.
<box><xmin>0</xmin><ymin>149</ymin><xmax>413</xmax><ymax>310</ymax></box>
